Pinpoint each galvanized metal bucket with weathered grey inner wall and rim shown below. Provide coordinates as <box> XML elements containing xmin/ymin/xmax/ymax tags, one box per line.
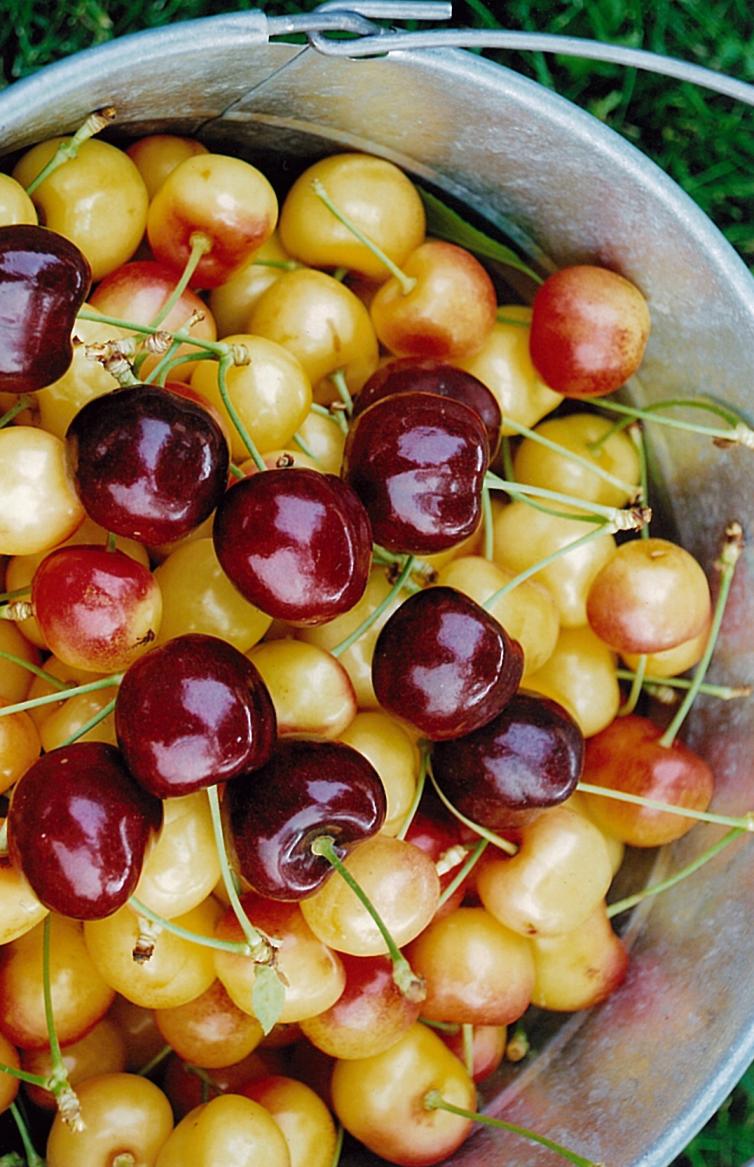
<box><xmin>0</xmin><ymin>12</ymin><xmax>754</xmax><ymax>1167</ymax></box>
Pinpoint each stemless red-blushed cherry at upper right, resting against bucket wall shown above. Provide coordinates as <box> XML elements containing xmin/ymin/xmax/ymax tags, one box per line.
<box><xmin>530</xmin><ymin>264</ymin><xmax>650</xmax><ymax>397</ymax></box>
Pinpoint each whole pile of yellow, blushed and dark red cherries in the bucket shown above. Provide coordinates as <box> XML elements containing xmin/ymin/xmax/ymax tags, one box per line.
<box><xmin>0</xmin><ymin>120</ymin><xmax>746</xmax><ymax>1167</ymax></box>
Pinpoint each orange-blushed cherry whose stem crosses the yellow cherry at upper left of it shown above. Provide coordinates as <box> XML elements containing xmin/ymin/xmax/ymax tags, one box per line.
<box><xmin>370</xmin><ymin>239</ymin><xmax>497</xmax><ymax>361</ymax></box>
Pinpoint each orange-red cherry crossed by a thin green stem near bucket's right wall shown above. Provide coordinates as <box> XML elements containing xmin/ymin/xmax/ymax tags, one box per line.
<box><xmin>584</xmin><ymin>714</ymin><xmax>714</xmax><ymax>847</ymax></box>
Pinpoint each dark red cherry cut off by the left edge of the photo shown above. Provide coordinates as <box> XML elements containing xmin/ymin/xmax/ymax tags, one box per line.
<box><xmin>0</xmin><ymin>224</ymin><xmax>91</xmax><ymax>393</ymax></box>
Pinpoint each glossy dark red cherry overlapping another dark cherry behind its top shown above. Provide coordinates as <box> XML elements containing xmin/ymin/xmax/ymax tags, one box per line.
<box><xmin>342</xmin><ymin>393</ymin><xmax>489</xmax><ymax>555</ymax></box>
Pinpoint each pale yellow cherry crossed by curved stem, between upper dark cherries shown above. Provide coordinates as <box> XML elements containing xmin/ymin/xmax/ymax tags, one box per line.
<box><xmin>191</xmin><ymin>333</ymin><xmax>312</xmax><ymax>461</ymax></box>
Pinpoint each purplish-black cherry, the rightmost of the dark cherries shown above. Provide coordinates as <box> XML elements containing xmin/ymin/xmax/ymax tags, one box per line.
<box><xmin>432</xmin><ymin>691</ymin><xmax>584</xmax><ymax>831</ymax></box>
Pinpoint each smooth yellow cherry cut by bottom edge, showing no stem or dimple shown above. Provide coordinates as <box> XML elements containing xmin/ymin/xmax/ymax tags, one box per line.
<box><xmin>154</xmin><ymin>1093</ymin><xmax>291</xmax><ymax>1167</ymax></box>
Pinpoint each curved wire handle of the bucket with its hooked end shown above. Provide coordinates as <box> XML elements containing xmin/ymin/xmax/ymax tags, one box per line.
<box><xmin>268</xmin><ymin>0</ymin><xmax>754</xmax><ymax>105</ymax></box>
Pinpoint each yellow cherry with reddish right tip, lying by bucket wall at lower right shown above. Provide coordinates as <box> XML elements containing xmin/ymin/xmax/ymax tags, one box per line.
<box><xmin>531</xmin><ymin>903</ymin><xmax>628</xmax><ymax>1013</ymax></box>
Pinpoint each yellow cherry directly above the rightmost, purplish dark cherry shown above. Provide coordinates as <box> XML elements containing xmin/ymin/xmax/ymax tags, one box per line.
<box><xmin>526</xmin><ymin>624</ymin><xmax>621</xmax><ymax>738</ymax></box>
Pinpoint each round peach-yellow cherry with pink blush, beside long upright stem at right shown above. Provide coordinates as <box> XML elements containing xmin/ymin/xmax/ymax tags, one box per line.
<box><xmin>586</xmin><ymin>538</ymin><xmax>711</xmax><ymax>652</ymax></box>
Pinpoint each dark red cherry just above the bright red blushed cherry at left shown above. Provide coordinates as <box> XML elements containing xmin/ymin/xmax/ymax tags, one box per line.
<box><xmin>67</xmin><ymin>385</ymin><xmax>229</xmax><ymax>545</ymax></box>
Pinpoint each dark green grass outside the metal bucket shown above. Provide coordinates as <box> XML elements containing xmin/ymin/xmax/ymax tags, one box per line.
<box><xmin>0</xmin><ymin>0</ymin><xmax>754</xmax><ymax>1167</ymax></box>
